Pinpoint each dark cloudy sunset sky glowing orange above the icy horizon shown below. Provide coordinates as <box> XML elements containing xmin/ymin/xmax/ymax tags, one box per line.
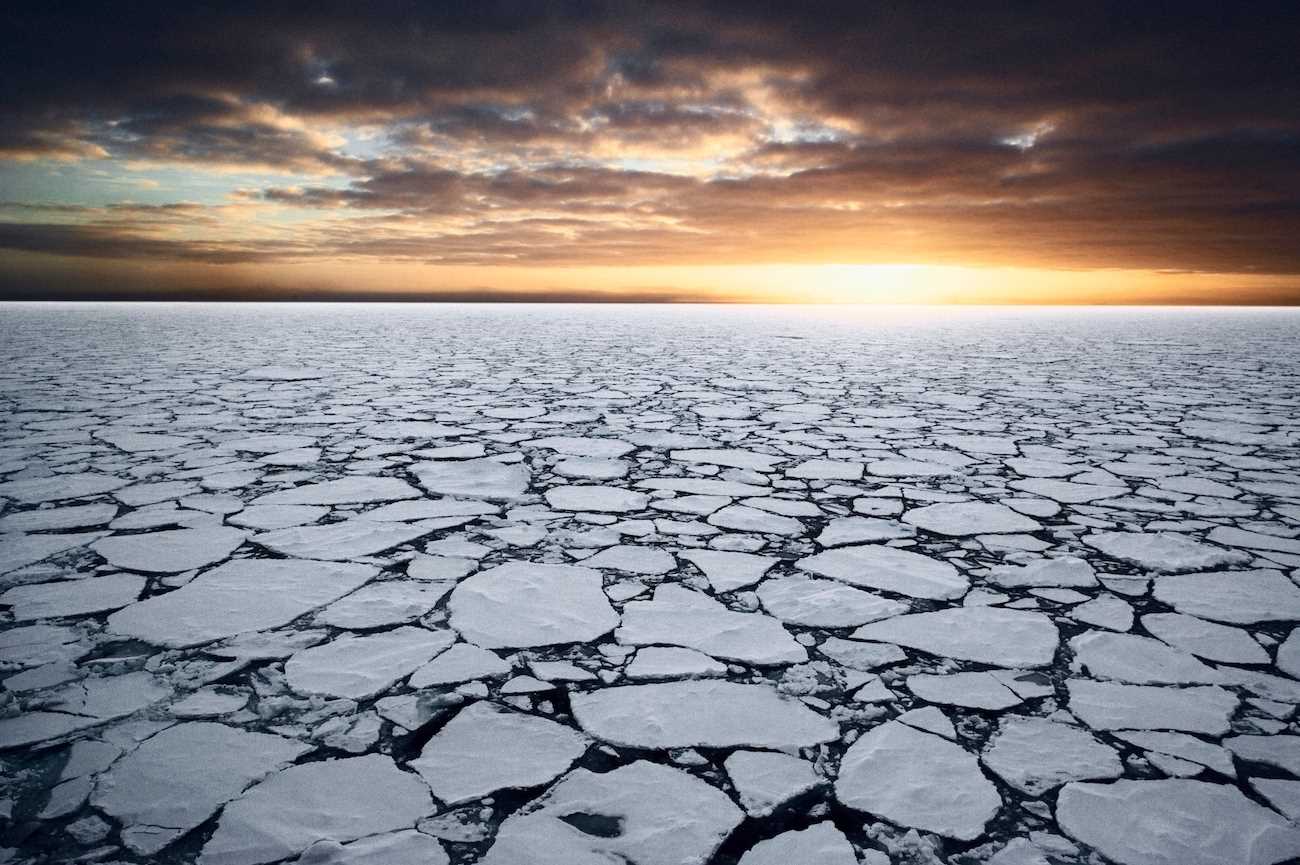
<box><xmin>0</xmin><ymin>0</ymin><xmax>1300</xmax><ymax>303</ymax></box>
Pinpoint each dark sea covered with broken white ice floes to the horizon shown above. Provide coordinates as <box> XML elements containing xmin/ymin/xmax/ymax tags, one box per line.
<box><xmin>0</xmin><ymin>304</ymin><xmax>1300</xmax><ymax>865</ymax></box>
